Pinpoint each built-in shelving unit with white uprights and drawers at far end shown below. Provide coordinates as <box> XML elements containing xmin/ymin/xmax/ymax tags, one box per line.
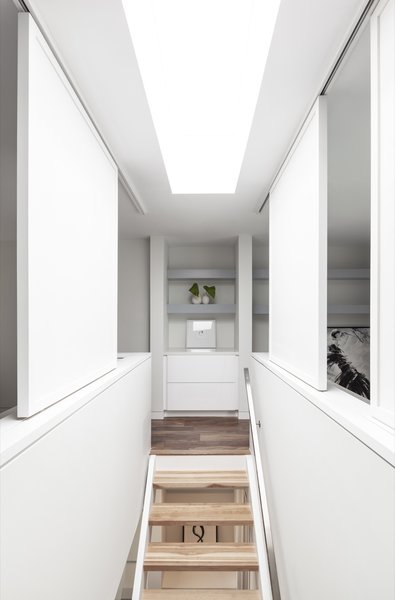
<box><xmin>151</xmin><ymin>236</ymin><xmax>252</xmax><ymax>414</ymax></box>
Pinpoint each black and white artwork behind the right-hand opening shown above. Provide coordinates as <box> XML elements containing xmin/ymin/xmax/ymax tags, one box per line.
<box><xmin>327</xmin><ymin>327</ymin><xmax>370</xmax><ymax>401</ymax></box>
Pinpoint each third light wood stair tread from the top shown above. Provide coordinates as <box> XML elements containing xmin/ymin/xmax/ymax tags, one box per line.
<box><xmin>144</xmin><ymin>542</ymin><xmax>258</xmax><ymax>571</ymax></box>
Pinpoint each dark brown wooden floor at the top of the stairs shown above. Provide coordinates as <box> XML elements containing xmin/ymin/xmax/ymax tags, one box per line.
<box><xmin>151</xmin><ymin>417</ymin><xmax>250</xmax><ymax>454</ymax></box>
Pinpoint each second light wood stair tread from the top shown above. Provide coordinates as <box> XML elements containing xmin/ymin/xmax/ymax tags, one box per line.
<box><xmin>149</xmin><ymin>502</ymin><xmax>253</xmax><ymax>525</ymax></box>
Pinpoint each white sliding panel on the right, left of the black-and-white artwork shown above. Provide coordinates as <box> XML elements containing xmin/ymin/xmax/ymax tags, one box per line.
<box><xmin>269</xmin><ymin>97</ymin><xmax>327</xmax><ymax>390</ymax></box>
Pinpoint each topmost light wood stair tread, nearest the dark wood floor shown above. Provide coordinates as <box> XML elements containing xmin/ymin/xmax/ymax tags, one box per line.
<box><xmin>153</xmin><ymin>471</ymin><xmax>248</xmax><ymax>490</ymax></box>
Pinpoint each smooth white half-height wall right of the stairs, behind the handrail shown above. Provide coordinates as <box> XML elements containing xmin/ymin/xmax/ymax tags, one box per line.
<box><xmin>251</xmin><ymin>359</ymin><xmax>395</xmax><ymax>600</ymax></box>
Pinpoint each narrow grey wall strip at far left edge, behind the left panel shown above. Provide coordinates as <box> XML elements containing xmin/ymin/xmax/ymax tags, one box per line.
<box><xmin>0</xmin><ymin>0</ymin><xmax>18</xmax><ymax>411</ymax></box>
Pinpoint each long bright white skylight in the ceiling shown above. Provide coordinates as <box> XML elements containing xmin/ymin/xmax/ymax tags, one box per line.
<box><xmin>122</xmin><ymin>0</ymin><xmax>280</xmax><ymax>194</ymax></box>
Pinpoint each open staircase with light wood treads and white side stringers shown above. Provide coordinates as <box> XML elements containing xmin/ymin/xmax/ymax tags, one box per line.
<box><xmin>133</xmin><ymin>456</ymin><xmax>269</xmax><ymax>600</ymax></box>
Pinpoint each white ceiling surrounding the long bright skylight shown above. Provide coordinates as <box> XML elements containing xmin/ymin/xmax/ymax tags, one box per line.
<box><xmin>27</xmin><ymin>0</ymin><xmax>372</xmax><ymax>244</ymax></box>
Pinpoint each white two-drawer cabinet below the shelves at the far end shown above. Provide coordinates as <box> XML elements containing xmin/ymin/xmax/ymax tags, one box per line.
<box><xmin>166</xmin><ymin>353</ymin><xmax>238</xmax><ymax>411</ymax></box>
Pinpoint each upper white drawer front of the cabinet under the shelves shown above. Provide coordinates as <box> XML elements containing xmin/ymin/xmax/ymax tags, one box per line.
<box><xmin>167</xmin><ymin>356</ymin><xmax>238</xmax><ymax>383</ymax></box>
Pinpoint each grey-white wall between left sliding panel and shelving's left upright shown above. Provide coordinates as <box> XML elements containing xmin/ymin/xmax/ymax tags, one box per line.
<box><xmin>118</xmin><ymin>238</ymin><xmax>150</xmax><ymax>352</ymax></box>
